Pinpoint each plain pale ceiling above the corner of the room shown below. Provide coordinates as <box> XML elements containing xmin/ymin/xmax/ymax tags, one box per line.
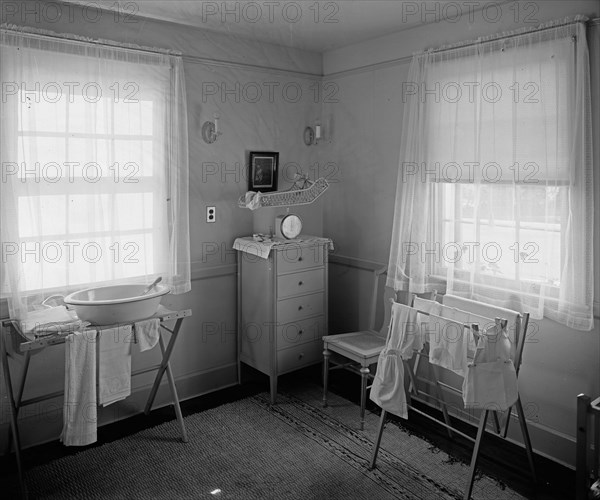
<box><xmin>64</xmin><ymin>0</ymin><xmax>442</xmax><ymax>52</ymax></box>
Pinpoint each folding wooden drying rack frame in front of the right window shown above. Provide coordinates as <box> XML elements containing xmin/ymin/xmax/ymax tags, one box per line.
<box><xmin>370</xmin><ymin>298</ymin><xmax>537</xmax><ymax>500</ymax></box>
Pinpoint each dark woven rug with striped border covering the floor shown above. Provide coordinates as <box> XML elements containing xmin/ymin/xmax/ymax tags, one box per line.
<box><xmin>3</xmin><ymin>387</ymin><xmax>522</xmax><ymax>500</ymax></box>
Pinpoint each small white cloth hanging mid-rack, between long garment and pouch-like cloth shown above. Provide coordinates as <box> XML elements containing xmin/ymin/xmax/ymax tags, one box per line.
<box><xmin>428</xmin><ymin>314</ymin><xmax>468</xmax><ymax>375</ymax></box>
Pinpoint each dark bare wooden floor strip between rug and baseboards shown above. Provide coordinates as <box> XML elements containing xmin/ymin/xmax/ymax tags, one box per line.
<box><xmin>0</xmin><ymin>367</ymin><xmax>575</xmax><ymax>500</ymax></box>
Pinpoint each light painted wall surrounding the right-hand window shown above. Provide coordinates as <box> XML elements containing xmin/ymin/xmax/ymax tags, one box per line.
<box><xmin>322</xmin><ymin>1</ymin><xmax>600</xmax><ymax>466</ymax></box>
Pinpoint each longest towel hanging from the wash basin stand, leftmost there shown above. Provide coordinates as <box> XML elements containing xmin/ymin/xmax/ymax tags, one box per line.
<box><xmin>60</xmin><ymin>330</ymin><xmax>97</xmax><ymax>446</ymax></box>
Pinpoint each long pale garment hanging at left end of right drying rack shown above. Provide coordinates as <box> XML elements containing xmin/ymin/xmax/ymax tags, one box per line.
<box><xmin>369</xmin><ymin>302</ymin><xmax>417</xmax><ymax>419</ymax></box>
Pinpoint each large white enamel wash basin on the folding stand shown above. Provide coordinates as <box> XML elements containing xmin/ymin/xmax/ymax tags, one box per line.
<box><xmin>65</xmin><ymin>284</ymin><xmax>171</xmax><ymax>325</ymax></box>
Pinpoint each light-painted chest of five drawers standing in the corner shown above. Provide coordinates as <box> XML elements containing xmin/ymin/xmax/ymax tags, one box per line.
<box><xmin>238</xmin><ymin>239</ymin><xmax>329</xmax><ymax>403</ymax></box>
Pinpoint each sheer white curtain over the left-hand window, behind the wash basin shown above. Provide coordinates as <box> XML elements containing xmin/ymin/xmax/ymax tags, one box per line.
<box><xmin>0</xmin><ymin>25</ymin><xmax>190</xmax><ymax>318</ymax></box>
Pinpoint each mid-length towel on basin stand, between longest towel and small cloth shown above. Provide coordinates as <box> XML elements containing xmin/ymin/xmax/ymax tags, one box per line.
<box><xmin>98</xmin><ymin>325</ymin><xmax>132</xmax><ymax>406</ymax></box>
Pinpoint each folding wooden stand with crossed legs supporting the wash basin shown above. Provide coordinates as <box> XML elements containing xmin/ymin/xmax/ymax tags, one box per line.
<box><xmin>0</xmin><ymin>306</ymin><xmax>192</xmax><ymax>498</ymax></box>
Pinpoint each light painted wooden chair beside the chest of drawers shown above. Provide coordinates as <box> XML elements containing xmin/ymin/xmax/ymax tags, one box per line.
<box><xmin>323</xmin><ymin>267</ymin><xmax>395</xmax><ymax>430</ymax></box>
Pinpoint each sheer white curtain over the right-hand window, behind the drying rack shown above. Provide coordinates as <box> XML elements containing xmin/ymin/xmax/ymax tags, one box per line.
<box><xmin>388</xmin><ymin>18</ymin><xmax>594</xmax><ymax>330</ymax></box>
